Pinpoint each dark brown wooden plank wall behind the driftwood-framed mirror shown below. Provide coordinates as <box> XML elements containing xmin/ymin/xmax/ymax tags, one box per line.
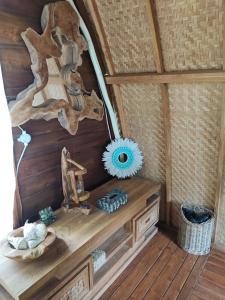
<box><xmin>0</xmin><ymin>0</ymin><xmax>112</xmax><ymax>220</ymax></box>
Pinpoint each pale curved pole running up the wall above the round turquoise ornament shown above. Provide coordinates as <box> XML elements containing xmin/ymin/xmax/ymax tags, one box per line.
<box><xmin>67</xmin><ymin>0</ymin><xmax>121</xmax><ymax>139</ymax></box>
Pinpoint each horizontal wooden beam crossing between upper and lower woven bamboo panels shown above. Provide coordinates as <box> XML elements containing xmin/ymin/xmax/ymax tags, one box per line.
<box><xmin>105</xmin><ymin>70</ymin><xmax>225</xmax><ymax>84</ymax></box>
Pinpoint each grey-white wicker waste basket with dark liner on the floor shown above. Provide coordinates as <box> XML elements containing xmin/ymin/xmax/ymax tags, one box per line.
<box><xmin>178</xmin><ymin>204</ymin><xmax>215</xmax><ymax>255</ymax></box>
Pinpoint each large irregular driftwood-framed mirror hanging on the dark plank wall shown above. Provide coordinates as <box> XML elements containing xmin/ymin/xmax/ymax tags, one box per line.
<box><xmin>10</xmin><ymin>1</ymin><xmax>104</xmax><ymax>135</ymax></box>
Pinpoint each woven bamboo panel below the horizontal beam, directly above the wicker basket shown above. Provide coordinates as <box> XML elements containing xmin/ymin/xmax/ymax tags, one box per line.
<box><xmin>169</xmin><ymin>84</ymin><xmax>223</xmax><ymax>212</ymax></box>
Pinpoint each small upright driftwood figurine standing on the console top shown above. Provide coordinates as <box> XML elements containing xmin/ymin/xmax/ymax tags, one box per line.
<box><xmin>61</xmin><ymin>147</ymin><xmax>91</xmax><ymax>214</ymax></box>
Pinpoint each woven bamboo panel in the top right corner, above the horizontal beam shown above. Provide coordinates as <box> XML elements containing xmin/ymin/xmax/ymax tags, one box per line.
<box><xmin>155</xmin><ymin>0</ymin><xmax>223</xmax><ymax>71</ymax></box>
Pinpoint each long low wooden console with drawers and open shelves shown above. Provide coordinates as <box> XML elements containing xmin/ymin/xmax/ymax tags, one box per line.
<box><xmin>0</xmin><ymin>178</ymin><xmax>160</xmax><ymax>300</ymax></box>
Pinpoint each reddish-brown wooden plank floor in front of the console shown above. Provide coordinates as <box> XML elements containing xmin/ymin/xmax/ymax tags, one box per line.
<box><xmin>100</xmin><ymin>233</ymin><xmax>225</xmax><ymax>300</ymax></box>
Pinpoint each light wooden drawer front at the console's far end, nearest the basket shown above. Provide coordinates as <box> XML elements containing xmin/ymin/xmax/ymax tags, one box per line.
<box><xmin>135</xmin><ymin>202</ymin><xmax>159</xmax><ymax>241</ymax></box>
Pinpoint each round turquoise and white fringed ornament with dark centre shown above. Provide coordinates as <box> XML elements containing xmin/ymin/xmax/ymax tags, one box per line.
<box><xmin>102</xmin><ymin>138</ymin><xmax>143</xmax><ymax>178</ymax></box>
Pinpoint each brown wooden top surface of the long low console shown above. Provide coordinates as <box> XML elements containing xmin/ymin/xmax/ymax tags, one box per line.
<box><xmin>0</xmin><ymin>177</ymin><xmax>160</xmax><ymax>298</ymax></box>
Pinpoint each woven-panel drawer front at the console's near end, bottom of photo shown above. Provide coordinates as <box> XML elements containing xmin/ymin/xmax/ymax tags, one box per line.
<box><xmin>51</xmin><ymin>266</ymin><xmax>90</xmax><ymax>300</ymax></box>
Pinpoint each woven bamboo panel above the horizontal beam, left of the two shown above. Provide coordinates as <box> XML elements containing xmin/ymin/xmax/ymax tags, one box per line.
<box><xmin>96</xmin><ymin>0</ymin><xmax>155</xmax><ymax>73</ymax></box>
